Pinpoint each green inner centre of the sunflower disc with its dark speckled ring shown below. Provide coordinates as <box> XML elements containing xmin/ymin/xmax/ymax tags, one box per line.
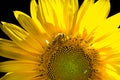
<box><xmin>48</xmin><ymin>47</ymin><xmax>91</xmax><ymax>80</ymax></box>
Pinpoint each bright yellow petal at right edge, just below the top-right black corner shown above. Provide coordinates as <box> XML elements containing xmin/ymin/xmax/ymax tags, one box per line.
<box><xmin>94</xmin><ymin>13</ymin><xmax>120</xmax><ymax>42</ymax></box>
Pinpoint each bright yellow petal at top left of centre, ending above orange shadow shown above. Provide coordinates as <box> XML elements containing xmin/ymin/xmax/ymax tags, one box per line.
<box><xmin>38</xmin><ymin>0</ymin><xmax>55</xmax><ymax>25</ymax></box>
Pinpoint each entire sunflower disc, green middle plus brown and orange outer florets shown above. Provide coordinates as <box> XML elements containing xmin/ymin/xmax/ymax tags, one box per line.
<box><xmin>38</xmin><ymin>34</ymin><xmax>101</xmax><ymax>80</ymax></box>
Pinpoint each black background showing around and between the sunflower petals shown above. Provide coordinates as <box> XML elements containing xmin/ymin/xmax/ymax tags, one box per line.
<box><xmin>0</xmin><ymin>0</ymin><xmax>120</xmax><ymax>77</ymax></box>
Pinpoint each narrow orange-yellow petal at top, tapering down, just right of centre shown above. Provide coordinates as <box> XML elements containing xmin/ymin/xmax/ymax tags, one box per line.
<box><xmin>61</xmin><ymin>0</ymin><xmax>79</xmax><ymax>33</ymax></box>
